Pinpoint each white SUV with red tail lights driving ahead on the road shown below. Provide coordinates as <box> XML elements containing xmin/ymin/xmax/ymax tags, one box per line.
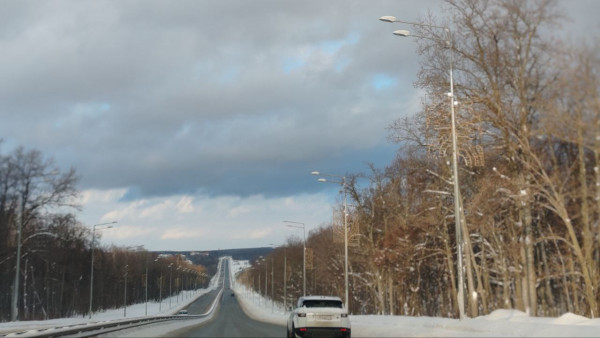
<box><xmin>287</xmin><ymin>296</ymin><xmax>350</xmax><ymax>338</ymax></box>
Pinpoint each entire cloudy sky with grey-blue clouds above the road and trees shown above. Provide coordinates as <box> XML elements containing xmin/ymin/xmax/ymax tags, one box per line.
<box><xmin>0</xmin><ymin>0</ymin><xmax>600</xmax><ymax>250</ymax></box>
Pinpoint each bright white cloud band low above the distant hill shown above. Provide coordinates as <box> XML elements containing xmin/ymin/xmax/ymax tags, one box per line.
<box><xmin>76</xmin><ymin>190</ymin><xmax>332</xmax><ymax>250</ymax></box>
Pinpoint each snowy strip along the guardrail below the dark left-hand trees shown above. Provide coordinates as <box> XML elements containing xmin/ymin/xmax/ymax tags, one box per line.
<box><xmin>0</xmin><ymin>262</ymin><xmax>219</xmax><ymax>335</ymax></box>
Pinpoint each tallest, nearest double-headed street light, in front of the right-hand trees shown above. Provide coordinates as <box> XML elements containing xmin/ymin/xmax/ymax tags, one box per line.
<box><xmin>379</xmin><ymin>16</ymin><xmax>465</xmax><ymax>319</ymax></box>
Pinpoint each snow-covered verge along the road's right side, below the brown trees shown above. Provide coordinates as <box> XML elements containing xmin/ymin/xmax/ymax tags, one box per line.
<box><xmin>229</xmin><ymin>261</ymin><xmax>600</xmax><ymax>337</ymax></box>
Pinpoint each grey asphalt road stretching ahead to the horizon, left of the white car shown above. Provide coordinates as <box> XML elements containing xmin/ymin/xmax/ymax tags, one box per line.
<box><xmin>171</xmin><ymin>261</ymin><xmax>286</xmax><ymax>337</ymax></box>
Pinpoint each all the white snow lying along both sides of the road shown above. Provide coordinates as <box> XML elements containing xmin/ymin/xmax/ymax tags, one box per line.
<box><xmin>0</xmin><ymin>261</ymin><xmax>600</xmax><ymax>337</ymax></box>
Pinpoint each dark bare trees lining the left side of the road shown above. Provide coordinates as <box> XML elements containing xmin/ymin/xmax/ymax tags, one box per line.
<box><xmin>0</xmin><ymin>147</ymin><xmax>208</xmax><ymax>321</ymax></box>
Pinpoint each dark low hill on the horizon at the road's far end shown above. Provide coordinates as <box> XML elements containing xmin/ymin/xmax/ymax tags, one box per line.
<box><xmin>154</xmin><ymin>247</ymin><xmax>273</xmax><ymax>275</ymax></box>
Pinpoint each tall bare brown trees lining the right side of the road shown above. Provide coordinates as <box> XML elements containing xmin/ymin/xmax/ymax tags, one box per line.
<box><xmin>240</xmin><ymin>0</ymin><xmax>600</xmax><ymax>318</ymax></box>
